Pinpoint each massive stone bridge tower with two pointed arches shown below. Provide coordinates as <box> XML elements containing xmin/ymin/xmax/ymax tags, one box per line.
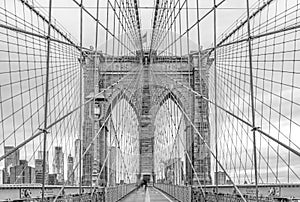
<box><xmin>83</xmin><ymin>51</ymin><xmax>212</xmax><ymax>185</ymax></box>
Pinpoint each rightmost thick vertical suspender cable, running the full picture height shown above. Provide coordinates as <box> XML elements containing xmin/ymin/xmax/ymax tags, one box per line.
<box><xmin>246</xmin><ymin>0</ymin><xmax>258</xmax><ymax>201</ymax></box>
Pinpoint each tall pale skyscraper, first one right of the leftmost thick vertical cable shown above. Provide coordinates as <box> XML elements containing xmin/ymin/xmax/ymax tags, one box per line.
<box><xmin>53</xmin><ymin>147</ymin><xmax>64</xmax><ymax>184</ymax></box>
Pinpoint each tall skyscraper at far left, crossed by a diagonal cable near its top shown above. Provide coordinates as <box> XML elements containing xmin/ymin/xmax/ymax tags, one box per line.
<box><xmin>3</xmin><ymin>146</ymin><xmax>20</xmax><ymax>184</ymax></box>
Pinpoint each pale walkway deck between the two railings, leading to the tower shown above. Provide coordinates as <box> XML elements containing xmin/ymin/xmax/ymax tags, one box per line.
<box><xmin>121</xmin><ymin>187</ymin><xmax>175</xmax><ymax>202</ymax></box>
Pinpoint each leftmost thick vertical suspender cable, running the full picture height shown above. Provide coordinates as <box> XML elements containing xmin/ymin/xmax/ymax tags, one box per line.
<box><xmin>42</xmin><ymin>0</ymin><xmax>52</xmax><ymax>202</ymax></box>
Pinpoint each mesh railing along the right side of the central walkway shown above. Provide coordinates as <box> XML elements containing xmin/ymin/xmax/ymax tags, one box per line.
<box><xmin>154</xmin><ymin>184</ymin><xmax>192</xmax><ymax>202</ymax></box>
